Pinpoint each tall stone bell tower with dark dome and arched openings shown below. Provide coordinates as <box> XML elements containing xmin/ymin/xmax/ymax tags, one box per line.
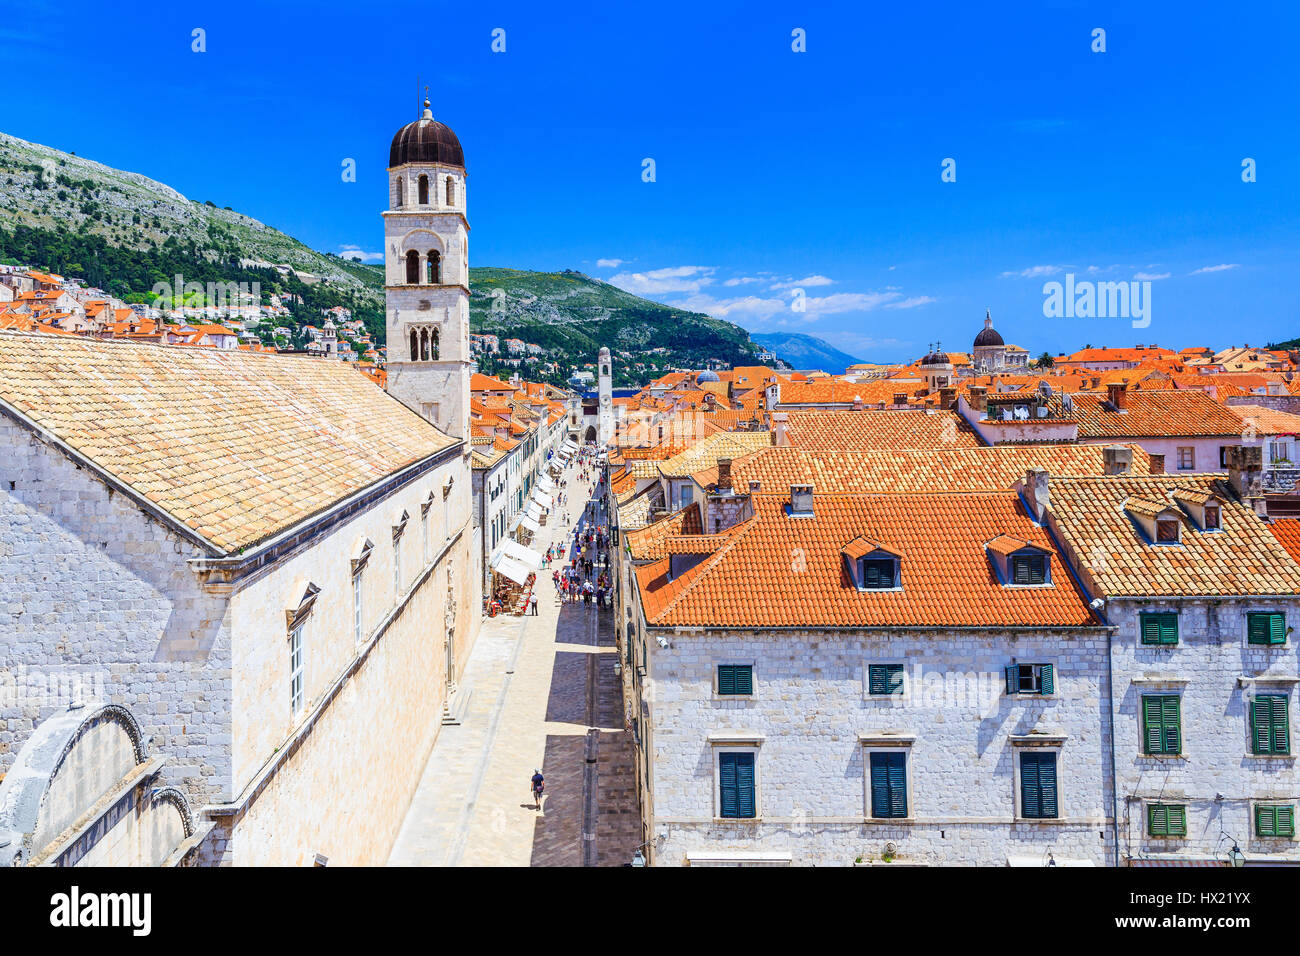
<box><xmin>384</xmin><ymin>100</ymin><xmax>472</xmax><ymax>442</ymax></box>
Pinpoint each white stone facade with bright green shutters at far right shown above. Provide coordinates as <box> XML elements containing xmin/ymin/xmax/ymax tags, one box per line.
<box><xmin>1106</xmin><ymin>596</ymin><xmax>1300</xmax><ymax>860</ymax></box>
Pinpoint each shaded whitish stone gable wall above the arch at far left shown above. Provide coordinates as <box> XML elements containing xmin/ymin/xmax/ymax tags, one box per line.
<box><xmin>0</xmin><ymin>416</ymin><xmax>231</xmax><ymax>805</ymax></box>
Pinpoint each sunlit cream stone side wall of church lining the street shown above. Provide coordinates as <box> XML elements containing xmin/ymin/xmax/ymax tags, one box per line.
<box><xmin>222</xmin><ymin>457</ymin><xmax>481</xmax><ymax>865</ymax></box>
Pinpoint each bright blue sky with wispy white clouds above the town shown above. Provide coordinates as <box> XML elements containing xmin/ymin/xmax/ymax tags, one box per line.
<box><xmin>0</xmin><ymin>0</ymin><xmax>1300</xmax><ymax>360</ymax></box>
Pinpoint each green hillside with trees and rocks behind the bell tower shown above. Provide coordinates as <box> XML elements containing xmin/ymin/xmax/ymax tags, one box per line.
<box><xmin>0</xmin><ymin>133</ymin><xmax>757</xmax><ymax>384</ymax></box>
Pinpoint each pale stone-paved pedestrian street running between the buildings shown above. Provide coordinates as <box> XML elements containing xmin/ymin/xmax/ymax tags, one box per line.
<box><xmin>389</xmin><ymin>455</ymin><xmax>641</xmax><ymax>866</ymax></box>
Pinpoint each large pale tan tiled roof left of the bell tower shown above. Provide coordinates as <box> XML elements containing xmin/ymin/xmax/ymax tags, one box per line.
<box><xmin>0</xmin><ymin>332</ymin><xmax>454</xmax><ymax>554</ymax></box>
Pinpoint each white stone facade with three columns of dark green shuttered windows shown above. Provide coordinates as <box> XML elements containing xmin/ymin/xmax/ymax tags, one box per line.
<box><xmin>642</xmin><ymin>631</ymin><xmax>1113</xmax><ymax>865</ymax></box>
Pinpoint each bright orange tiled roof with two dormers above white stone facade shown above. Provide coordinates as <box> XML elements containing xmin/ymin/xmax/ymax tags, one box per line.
<box><xmin>637</xmin><ymin>492</ymin><xmax>1096</xmax><ymax>628</ymax></box>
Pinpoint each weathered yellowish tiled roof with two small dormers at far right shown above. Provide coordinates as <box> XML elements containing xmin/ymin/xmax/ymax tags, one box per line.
<box><xmin>1049</xmin><ymin>475</ymin><xmax>1300</xmax><ymax>597</ymax></box>
